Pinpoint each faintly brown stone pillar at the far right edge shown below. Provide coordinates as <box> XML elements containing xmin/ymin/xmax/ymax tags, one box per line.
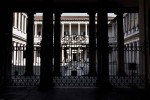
<box><xmin>139</xmin><ymin>0</ymin><xmax>150</xmax><ymax>89</ymax></box>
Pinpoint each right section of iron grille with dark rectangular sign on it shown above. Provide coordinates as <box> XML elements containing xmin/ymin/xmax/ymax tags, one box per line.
<box><xmin>109</xmin><ymin>45</ymin><xmax>145</xmax><ymax>88</ymax></box>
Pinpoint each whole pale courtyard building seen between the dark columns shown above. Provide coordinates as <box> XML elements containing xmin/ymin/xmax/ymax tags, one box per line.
<box><xmin>12</xmin><ymin>12</ymin><xmax>139</xmax><ymax>76</ymax></box>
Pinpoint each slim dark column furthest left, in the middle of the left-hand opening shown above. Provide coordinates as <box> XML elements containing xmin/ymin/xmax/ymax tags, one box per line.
<box><xmin>25</xmin><ymin>12</ymin><xmax>34</xmax><ymax>76</ymax></box>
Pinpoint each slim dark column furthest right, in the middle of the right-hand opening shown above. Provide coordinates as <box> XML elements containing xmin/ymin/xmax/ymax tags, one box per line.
<box><xmin>117</xmin><ymin>12</ymin><xmax>125</xmax><ymax>76</ymax></box>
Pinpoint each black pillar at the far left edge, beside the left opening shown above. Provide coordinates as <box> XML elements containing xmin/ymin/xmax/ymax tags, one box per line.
<box><xmin>0</xmin><ymin>8</ymin><xmax>13</xmax><ymax>88</ymax></box>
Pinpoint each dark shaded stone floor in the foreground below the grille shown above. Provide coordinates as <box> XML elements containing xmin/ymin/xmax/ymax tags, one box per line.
<box><xmin>0</xmin><ymin>87</ymin><xmax>150</xmax><ymax>100</ymax></box>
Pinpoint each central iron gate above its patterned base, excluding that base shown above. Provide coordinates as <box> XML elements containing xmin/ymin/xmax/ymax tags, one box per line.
<box><xmin>61</xmin><ymin>34</ymin><xmax>89</xmax><ymax>76</ymax></box>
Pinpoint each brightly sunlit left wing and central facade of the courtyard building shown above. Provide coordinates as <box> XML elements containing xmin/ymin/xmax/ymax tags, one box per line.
<box><xmin>12</xmin><ymin>12</ymin><xmax>114</xmax><ymax>76</ymax></box>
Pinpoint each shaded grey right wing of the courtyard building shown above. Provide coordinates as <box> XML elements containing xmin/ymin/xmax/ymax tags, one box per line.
<box><xmin>109</xmin><ymin>13</ymin><xmax>143</xmax><ymax>75</ymax></box>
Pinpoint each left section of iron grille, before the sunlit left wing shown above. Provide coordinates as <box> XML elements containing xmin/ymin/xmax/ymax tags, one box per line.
<box><xmin>8</xmin><ymin>46</ymin><xmax>40</xmax><ymax>86</ymax></box>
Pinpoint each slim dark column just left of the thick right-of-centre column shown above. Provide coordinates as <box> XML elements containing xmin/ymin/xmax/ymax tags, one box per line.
<box><xmin>89</xmin><ymin>12</ymin><xmax>96</xmax><ymax>76</ymax></box>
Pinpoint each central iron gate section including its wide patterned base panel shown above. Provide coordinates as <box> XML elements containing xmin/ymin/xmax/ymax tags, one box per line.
<box><xmin>54</xmin><ymin>35</ymin><xmax>97</xmax><ymax>87</ymax></box>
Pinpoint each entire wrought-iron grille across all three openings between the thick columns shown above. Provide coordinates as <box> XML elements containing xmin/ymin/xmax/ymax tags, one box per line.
<box><xmin>9</xmin><ymin>43</ymin><xmax>145</xmax><ymax>88</ymax></box>
